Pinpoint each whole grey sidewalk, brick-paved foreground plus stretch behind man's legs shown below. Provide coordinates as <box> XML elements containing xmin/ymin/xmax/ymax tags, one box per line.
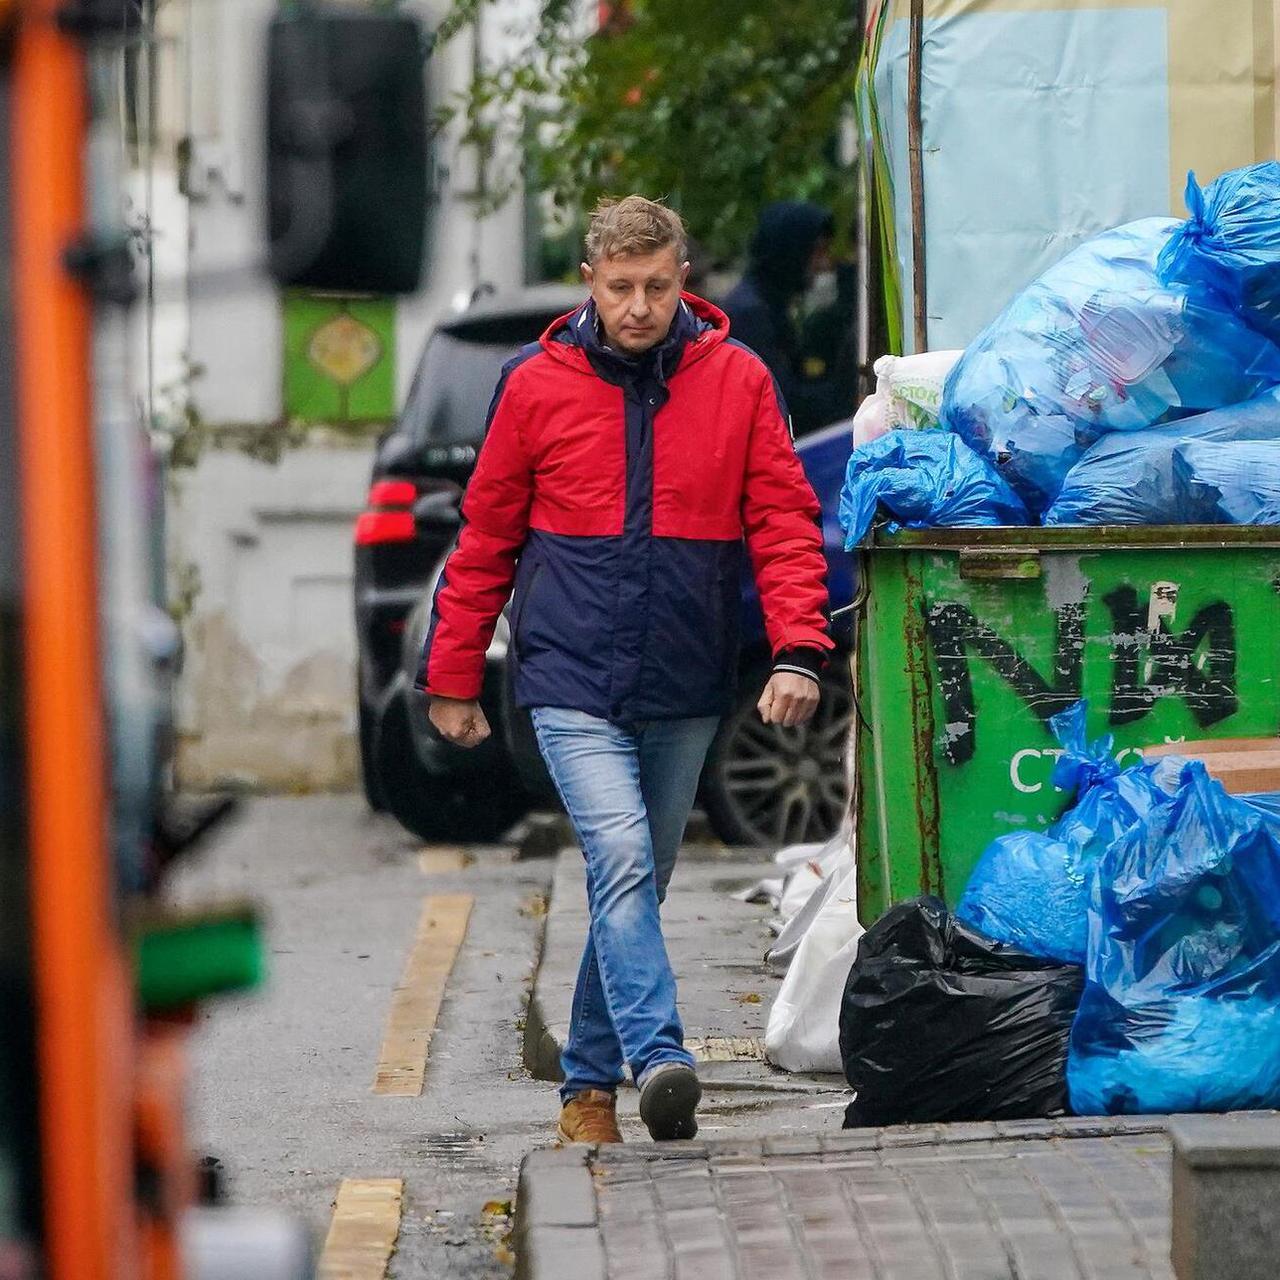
<box><xmin>515</xmin><ymin>847</ymin><xmax>1192</xmax><ymax>1280</ymax></box>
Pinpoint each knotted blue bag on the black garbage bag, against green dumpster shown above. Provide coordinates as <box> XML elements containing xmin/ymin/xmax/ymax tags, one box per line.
<box><xmin>956</xmin><ymin>701</ymin><xmax>1180</xmax><ymax>965</ymax></box>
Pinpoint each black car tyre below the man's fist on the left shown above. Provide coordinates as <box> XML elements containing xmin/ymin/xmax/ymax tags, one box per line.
<box><xmin>375</xmin><ymin>698</ymin><xmax>525</xmax><ymax>844</ymax></box>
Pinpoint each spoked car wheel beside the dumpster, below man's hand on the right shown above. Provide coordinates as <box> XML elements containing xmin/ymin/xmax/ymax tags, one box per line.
<box><xmin>703</xmin><ymin>668</ymin><xmax>854</xmax><ymax>847</ymax></box>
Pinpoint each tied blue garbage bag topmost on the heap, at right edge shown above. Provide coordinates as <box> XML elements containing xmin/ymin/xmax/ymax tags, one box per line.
<box><xmin>1157</xmin><ymin>160</ymin><xmax>1280</xmax><ymax>342</ymax></box>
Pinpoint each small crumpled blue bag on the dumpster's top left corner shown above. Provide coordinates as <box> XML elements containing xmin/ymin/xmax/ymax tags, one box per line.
<box><xmin>840</xmin><ymin>431</ymin><xmax>1030</xmax><ymax>550</ymax></box>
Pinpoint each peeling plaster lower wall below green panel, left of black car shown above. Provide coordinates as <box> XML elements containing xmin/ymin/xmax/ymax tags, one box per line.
<box><xmin>169</xmin><ymin>442</ymin><xmax>370</xmax><ymax>791</ymax></box>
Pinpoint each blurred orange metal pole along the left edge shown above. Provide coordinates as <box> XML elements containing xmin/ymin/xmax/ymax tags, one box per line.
<box><xmin>10</xmin><ymin>0</ymin><xmax>138</xmax><ymax>1280</ymax></box>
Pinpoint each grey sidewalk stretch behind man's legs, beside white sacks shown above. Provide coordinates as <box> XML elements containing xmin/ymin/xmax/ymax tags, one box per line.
<box><xmin>525</xmin><ymin>845</ymin><xmax>845</xmax><ymax>1093</ymax></box>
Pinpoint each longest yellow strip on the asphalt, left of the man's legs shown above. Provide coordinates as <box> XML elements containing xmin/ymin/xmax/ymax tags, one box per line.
<box><xmin>374</xmin><ymin>893</ymin><xmax>475</xmax><ymax>1097</ymax></box>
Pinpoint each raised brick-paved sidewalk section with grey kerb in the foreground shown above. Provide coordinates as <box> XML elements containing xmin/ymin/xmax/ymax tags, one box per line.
<box><xmin>515</xmin><ymin>1117</ymin><xmax>1172</xmax><ymax>1280</ymax></box>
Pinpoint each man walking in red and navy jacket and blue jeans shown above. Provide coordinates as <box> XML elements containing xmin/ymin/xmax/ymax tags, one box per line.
<box><xmin>419</xmin><ymin>196</ymin><xmax>831</xmax><ymax>1142</ymax></box>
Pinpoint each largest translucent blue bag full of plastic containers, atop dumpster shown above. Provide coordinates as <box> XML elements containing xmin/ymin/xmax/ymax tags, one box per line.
<box><xmin>942</xmin><ymin>218</ymin><xmax>1280</xmax><ymax>515</ymax></box>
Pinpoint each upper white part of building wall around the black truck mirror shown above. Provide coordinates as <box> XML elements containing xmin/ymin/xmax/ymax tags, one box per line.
<box><xmin>180</xmin><ymin>0</ymin><xmax>536</xmax><ymax>425</ymax></box>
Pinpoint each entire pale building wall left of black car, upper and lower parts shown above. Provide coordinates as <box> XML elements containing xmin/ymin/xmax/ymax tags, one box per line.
<box><xmin>168</xmin><ymin>0</ymin><xmax>536</xmax><ymax>790</ymax></box>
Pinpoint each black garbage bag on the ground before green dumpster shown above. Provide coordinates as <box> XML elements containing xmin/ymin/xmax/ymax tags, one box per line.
<box><xmin>840</xmin><ymin>897</ymin><xmax>1084</xmax><ymax>1129</ymax></box>
